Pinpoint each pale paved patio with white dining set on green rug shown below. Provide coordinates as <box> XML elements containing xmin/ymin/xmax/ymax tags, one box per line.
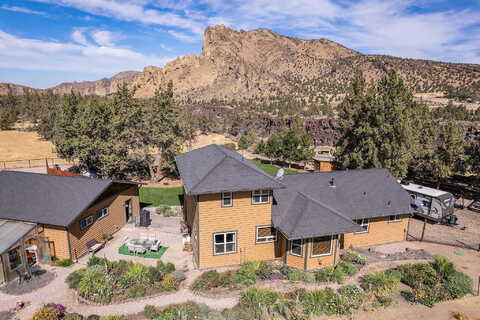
<box><xmin>79</xmin><ymin>213</ymin><xmax>194</xmax><ymax>271</ymax></box>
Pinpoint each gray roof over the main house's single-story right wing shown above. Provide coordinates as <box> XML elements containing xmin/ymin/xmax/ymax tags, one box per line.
<box><xmin>272</xmin><ymin>169</ymin><xmax>412</xmax><ymax>238</ymax></box>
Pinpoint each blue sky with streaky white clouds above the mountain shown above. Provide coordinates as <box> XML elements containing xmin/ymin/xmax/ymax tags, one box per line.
<box><xmin>0</xmin><ymin>0</ymin><xmax>480</xmax><ymax>88</ymax></box>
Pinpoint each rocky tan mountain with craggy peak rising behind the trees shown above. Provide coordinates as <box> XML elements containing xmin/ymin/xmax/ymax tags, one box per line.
<box><xmin>0</xmin><ymin>26</ymin><xmax>480</xmax><ymax>102</ymax></box>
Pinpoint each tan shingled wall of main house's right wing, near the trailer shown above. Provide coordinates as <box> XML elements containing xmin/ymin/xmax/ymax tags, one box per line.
<box><xmin>344</xmin><ymin>216</ymin><xmax>409</xmax><ymax>249</ymax></box>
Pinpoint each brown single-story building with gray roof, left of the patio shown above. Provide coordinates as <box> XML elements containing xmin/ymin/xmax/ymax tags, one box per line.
<box><xmin>0</xmin><ymin>171</ymin><xmax>140</xmax><ymax>280</ymax></box>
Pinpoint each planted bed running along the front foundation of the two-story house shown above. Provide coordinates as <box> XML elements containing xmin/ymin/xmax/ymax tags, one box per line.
<box><xmin>190</xmin><ymin>253</ymin><xmax>366</xmax><ymax>292</ymax></box>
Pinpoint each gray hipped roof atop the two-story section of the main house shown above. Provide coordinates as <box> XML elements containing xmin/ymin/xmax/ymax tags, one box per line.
<box><xmin>175</xmin><ymin>144</ymin><xmax>285</xmax><ymax>195</ymax></box>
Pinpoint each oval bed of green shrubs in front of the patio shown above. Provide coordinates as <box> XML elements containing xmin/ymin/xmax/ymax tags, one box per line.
<box><xmin>66</xmin><ymin>257</ymin><xmax>185</xmax><ymax>304</ymax></box>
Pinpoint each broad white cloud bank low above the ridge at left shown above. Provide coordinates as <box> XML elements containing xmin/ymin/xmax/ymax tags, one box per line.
<box><xmin>0</xmin><ymin>30</ymin><xmax>171</xmax><ymax>75</ymax></box>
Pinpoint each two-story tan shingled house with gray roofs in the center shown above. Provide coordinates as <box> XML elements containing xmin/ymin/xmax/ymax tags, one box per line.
<box><xmin>176</xmin><ymin>145</ymin><xmax>412</xmax><ymax>270</ymax></box>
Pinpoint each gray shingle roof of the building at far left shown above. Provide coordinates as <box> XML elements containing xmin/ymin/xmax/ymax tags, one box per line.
<box><xmin>0</xmin><ymin>171</ymin><xmax>113</xmax><ymax>227</ymax></box>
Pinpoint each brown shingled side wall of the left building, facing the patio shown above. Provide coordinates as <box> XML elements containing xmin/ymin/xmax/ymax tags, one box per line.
<box><xmin>69</xmin><ymin>186</ymin><xmax>140</xmax><ymax>260</ymax></box>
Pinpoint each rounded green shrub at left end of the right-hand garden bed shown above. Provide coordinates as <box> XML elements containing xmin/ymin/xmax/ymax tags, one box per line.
<box><xmin>361</xmin><ymin>270</ymin><xmax>401</xmax><ymax>298</ymax></box>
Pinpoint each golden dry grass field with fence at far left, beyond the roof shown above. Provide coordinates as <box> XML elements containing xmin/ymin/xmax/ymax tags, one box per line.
<box><xmin>0</xmin><ymin>130</ymin><xmax>57</xmax><ymax>167</ymax></box>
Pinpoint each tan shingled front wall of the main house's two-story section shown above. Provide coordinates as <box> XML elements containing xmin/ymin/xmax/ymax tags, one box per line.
<box><xmin>198</xmin><ymin>192</ymin><xmax>279</xmax><ymax>269</ymax></box>
